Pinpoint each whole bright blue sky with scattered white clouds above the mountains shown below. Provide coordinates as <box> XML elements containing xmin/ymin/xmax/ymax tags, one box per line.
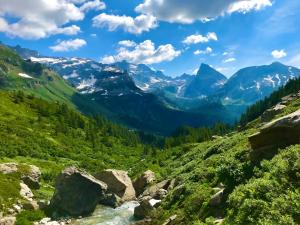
<box><xmin>0</xmin><ymin>0</ymin><xmax>300</xmax><ymax>76</ymax></box>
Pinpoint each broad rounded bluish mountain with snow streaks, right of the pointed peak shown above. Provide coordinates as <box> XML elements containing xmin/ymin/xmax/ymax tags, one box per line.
<box><xmin>220</xmin><ymin>62</ymin><xmax>300</xmax><ymax>105</ymax></box>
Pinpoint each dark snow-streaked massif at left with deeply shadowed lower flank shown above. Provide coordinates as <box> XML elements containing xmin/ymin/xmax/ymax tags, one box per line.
<box><xmin>31</xmin><ymin>54</ymin><xmax>233</xmax><ymax>135</ymax></box>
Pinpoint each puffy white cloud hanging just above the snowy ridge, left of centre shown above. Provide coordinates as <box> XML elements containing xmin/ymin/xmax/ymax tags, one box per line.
<box><xmin>101</xmin><ymin>40</ymin><xmax>181</xmax><ymax>65</ymax></box>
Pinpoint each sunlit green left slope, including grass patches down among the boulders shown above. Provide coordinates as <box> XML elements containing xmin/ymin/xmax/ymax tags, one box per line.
<box><xmin>0</xmin><ymin>91</ymin><xmax>143</xmax><ymax>218</ymax></box>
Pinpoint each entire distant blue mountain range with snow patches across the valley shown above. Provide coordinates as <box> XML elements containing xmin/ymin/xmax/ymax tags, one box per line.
<box><xmin>5</xmin><ymin>46</ymin><xmax>300</xmax><ymax>134</ymax></box>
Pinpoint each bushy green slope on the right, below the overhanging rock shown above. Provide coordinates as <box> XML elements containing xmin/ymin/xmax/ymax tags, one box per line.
<box><xmin>141</xmin><ymin>96</ymin><xmax>300</xmax><ymax>225</ymax></box>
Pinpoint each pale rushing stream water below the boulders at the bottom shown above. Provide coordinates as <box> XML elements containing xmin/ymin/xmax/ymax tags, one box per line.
<box><xmin>74</xmin><ymin>202</ymin><xmax>139</xmax><ymax>225</ymax></box>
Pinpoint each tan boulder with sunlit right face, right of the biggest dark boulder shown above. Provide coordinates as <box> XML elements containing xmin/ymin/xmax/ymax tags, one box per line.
<box><xmin>95</xmin><ymin>169</ymin><xmax>135</xmax><ymax>201</ymax></box>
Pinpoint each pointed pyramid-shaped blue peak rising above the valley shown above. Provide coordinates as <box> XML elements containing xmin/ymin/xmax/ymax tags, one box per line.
<box><xmin>184</xmin><ymin>64</ymin><xmax>227</xmax><ymax>98</ymax></box>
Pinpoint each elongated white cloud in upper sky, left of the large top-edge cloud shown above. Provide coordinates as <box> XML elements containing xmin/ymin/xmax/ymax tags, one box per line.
<box><xmin>93</xmin><ymin>13</ymin><xmax>157</xmax><ymax>34</ymax></box>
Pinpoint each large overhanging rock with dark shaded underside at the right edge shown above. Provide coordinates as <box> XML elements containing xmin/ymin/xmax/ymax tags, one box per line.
<box><xmin>249</xmin><ymin>110</ymin><xmax>300</xmax><ymax>152</ymax></box>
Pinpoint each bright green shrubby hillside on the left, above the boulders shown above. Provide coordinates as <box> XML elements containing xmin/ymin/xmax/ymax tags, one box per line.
<box><xmin>0</xmin><ymin>91</ymin><xmax>143</xmax><ymax>171</ymax></box>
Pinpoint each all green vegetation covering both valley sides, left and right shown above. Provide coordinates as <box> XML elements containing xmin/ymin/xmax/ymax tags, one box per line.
<box><xmin>0</xmin><ymin>46</ymin><xmax>300</xmax><ymax>225</ymax></box>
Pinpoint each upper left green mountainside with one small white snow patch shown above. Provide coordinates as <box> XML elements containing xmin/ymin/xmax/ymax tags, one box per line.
<box><xmin>0</xmin><ymin>45</ymin><xmax>76</xmax><ymax>104</ymax></box>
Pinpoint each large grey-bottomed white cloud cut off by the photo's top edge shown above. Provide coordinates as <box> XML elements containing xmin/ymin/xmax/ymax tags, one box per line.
<box><xmin>135</xmin><ymin>0</ymin><xmax>272</xmax><ymax>23</ymax></box>
